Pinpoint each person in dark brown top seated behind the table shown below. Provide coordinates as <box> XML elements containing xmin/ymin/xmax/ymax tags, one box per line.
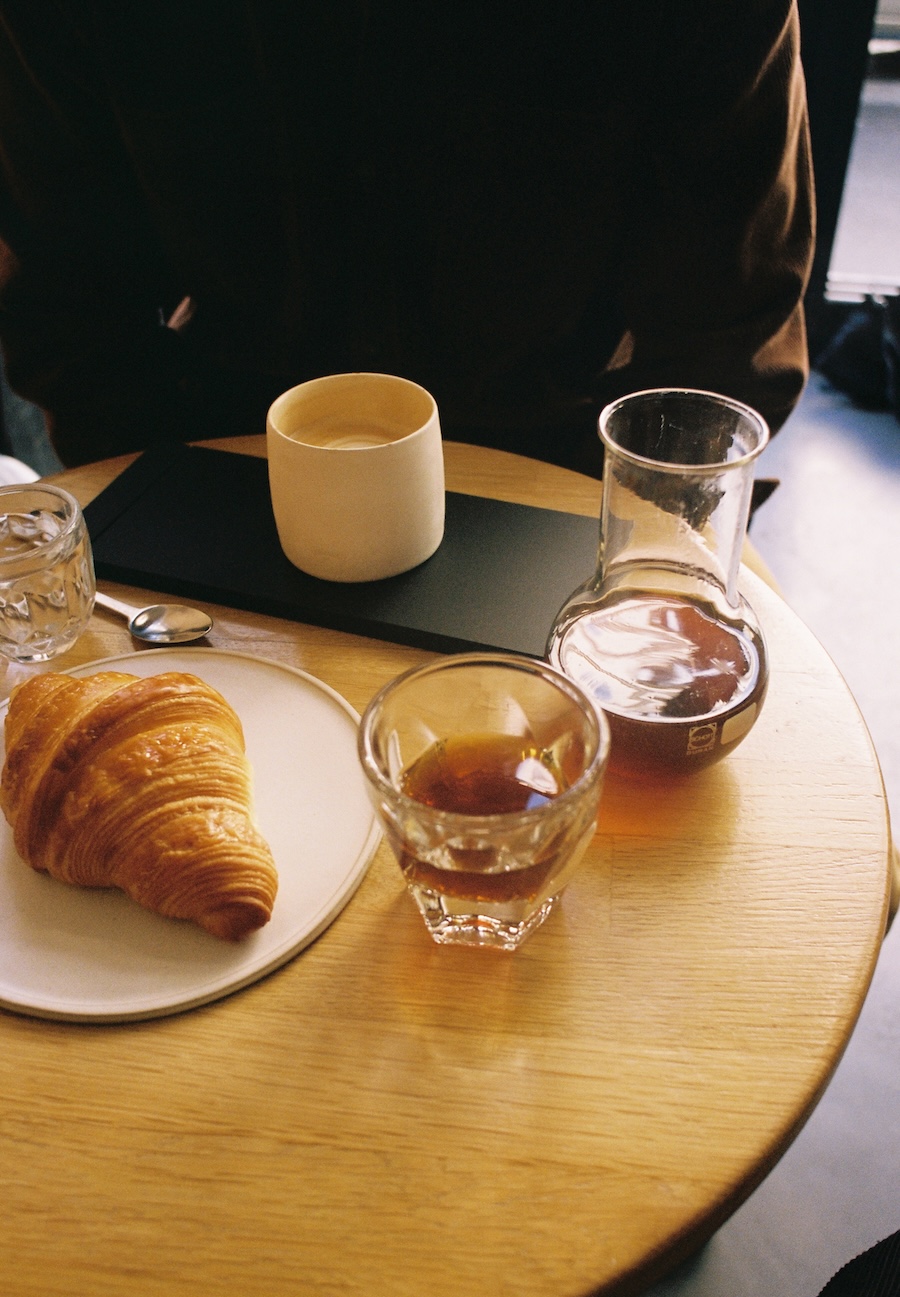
<box><xmin>0</xmin><ymin>0</ymin><xmax>813</xmax><ymax>472</ymax></box>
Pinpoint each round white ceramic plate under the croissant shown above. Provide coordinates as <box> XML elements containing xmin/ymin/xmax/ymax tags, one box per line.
<box><xmin>0</xmin><ymin>649</ymin><xmax>380</xmax><ymax>1022</ymax></box>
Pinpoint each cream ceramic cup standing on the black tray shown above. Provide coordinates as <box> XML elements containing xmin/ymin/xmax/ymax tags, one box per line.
<box><xmin>266</xmin><ymin>374</ymin><xmax>444</xmax><ymax>581</ymax></box>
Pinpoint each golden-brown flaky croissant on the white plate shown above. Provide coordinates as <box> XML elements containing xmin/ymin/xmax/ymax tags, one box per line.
<box><xmin>0</xmin><ymin>671</ymin><xmax>278</xmax><ymax>940</ymax></box>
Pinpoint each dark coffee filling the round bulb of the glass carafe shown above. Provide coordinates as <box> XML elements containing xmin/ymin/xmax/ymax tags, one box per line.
<box><xmin>550</xmin><ymin>591</ymin><xmax>768</xmax><ymax>774</ymax></box>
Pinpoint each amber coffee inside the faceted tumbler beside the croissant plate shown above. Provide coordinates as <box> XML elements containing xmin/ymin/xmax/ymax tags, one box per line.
<box><xmin>398</xmin><ymin>734</ymin><xmax>571</xmax><ymax>901</ymax></box>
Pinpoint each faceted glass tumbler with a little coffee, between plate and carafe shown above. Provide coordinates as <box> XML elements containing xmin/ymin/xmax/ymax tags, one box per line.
<box><xmin>359</xmin><ymin>654</ymin><xmax>610</xmax><ymax>951</ymax></box>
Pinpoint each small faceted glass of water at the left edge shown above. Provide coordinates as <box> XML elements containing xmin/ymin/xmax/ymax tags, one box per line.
<box><xmin>0</xmin><ymin>482</ymin><xmax>96</xmax><ymax>663</ymax></box>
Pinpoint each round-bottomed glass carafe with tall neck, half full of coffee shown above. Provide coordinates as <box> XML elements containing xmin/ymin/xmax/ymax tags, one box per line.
<box><xmin>547</xmin><ymin>388</ymin><xmax>769</xmax><ymax>776</ymax></box>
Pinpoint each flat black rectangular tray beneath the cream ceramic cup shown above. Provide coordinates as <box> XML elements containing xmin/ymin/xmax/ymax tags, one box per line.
<box><xmin>84</xmin><ymin>444</ymin><xmax>598</xmax><ymax>658</ymax></box>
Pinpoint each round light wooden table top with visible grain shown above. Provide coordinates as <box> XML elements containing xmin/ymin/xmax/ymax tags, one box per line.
<box><xmin>0</xmin><ymin>438</ymin><xmax>888</xmax><ymax>1297</ymax></box>
